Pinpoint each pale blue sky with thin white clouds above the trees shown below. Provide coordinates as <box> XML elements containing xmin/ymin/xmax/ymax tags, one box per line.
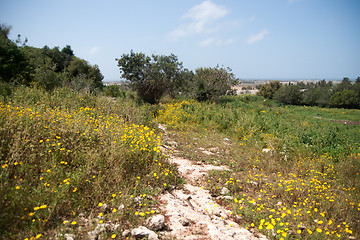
<box><xmin>0</xmin><ymin>0</ymin><xmax>360</xmax><ymax>80</ymax></box>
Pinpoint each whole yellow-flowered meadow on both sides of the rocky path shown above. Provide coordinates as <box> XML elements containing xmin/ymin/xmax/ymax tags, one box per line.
<box><xmin>0</xmin><ymin>87</ymin><xmax>360</xmax><ymax>239</ymax></box>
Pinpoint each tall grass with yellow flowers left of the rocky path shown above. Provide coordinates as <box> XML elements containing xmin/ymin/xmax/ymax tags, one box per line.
<box><xmin>0</xmin><ymin>87</ymin><xmax>179</xmax><ymax>239</ymax></box>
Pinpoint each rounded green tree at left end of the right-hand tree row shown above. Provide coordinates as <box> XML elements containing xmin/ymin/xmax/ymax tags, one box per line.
<box><xmin>274</xmin><ymin>85</ymin><xmax>302</xmax><ymax>105</ymax></box>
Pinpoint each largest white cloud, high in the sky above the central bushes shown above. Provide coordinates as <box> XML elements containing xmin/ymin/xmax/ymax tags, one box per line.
<box><xmin>168</xmin><ymin>0</ymin><xmax>229</xmax><ymax>41</ymax></box>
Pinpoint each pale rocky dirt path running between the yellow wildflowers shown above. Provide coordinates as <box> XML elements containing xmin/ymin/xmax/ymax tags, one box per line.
<box><xmin>160</xmin><ymin>126</ymin><xmax>267</xmax><ymax>240</ymax></box>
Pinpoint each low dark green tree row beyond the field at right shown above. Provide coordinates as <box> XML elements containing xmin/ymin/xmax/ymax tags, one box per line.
<box><xmin>258</xmin><ymin>77</ymin><xmax>360</xmax><ymax>109</ymax></box>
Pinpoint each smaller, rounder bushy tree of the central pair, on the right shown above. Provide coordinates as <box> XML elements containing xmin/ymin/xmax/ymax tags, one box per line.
<box><xmin>194</xmin><ymin>66</ymin><xmax>238</xmax><ymax>101</ymax></box>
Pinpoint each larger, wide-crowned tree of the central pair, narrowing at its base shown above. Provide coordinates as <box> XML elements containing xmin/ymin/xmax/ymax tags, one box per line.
<box><xmin>115</xmin><ymin>50</ymin><xmax>182</xmax><ymax>104</ymax></box>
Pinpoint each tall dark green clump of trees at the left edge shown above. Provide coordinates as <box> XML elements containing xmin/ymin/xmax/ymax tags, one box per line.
<box><xmin>0</xmin><ymin>24</ymin><xmax>104</xmax><ymax>94</ymax></box>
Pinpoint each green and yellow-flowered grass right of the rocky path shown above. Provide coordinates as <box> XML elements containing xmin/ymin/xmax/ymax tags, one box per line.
<box><xmin>157</xmin><ymin>96</ymin><xmax>360</xmax><ymax>239</ymax></box>
